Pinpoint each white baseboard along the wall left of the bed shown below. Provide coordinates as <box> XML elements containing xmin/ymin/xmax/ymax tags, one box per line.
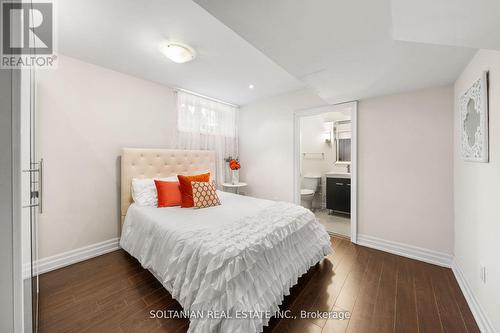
<box><xmin>23</xmin><ymin>238</ymin><xmax>120</xmax><ymax>279</ymax></box>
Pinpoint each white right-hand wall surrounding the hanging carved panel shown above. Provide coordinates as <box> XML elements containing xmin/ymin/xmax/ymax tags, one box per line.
<box><xmin>454</xmin><ymin>50</ymin><xmax>500</xmax><ymax>331</ymax></box>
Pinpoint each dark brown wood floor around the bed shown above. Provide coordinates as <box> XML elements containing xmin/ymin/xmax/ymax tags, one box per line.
<box><xmin>40</xmin><ymin>238</ymin><xmax>479</xmax><ymax>333</ymax></box>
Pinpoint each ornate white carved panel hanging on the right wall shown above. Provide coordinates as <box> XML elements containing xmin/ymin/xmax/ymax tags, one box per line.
<box><xmin>459</xmin><ymin>71</ymin><xmax>489</xmax><ymax>163</ymax></box>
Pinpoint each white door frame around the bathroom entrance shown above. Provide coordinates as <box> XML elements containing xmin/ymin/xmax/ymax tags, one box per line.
<box><xmin>293</xmin><ymin>101</ymin><xmax>358</xmax><ymax>243</ymax></box>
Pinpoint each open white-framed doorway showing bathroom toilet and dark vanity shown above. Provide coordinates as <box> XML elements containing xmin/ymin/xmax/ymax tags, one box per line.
<box><xmin>294</xmin><ymin>102</ymin><xmax>357</xmax><ymax>243</ymax></box>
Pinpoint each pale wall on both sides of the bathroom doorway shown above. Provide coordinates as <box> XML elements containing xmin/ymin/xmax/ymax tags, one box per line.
<box><xmin>240</xmin><ymin>87</ymin><xmax>453</xmax><ymax>254</ymax></box>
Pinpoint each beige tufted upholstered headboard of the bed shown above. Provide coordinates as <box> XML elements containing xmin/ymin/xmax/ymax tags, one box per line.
<box><xmin>121</xmin><ymin>148</ymin><xmax>217</xmax><ymax>224</ymax></box>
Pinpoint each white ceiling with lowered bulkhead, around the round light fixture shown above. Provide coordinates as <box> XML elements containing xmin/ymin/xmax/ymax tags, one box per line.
<box><xmin>56</xmin><ymin>0</ymin><xmax>500</xmax><ymax>105</ymax></box>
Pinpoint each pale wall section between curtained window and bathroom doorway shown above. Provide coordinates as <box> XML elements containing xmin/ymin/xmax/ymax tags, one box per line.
<box><xmin>239</xmin><ymin>90</ymin><xmax>325</xmax><ymax>202</ymax></box>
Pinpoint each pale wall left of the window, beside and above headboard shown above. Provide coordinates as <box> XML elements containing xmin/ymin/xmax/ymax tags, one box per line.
<box><xmin>37</xmin><ymin>56</ymin><xmax>176</xmax><ymax>258</ymax></box>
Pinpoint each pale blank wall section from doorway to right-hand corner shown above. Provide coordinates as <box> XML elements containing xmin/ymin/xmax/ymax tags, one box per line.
<box><xmin>358</xmin><ymin>87</ymin><xmax>453</xmax><ymax>254</ymax></box>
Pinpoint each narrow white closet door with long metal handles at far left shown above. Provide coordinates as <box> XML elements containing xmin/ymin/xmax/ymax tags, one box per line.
<box><xmin>13</xmin><ymin>68</ymin><xmax>42</xmax><ymax>333</ymax></box>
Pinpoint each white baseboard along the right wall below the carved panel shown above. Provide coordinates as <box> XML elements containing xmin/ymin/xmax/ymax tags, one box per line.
<box><xmin>451</xmin><ymin>259</ymin><xmax>496</xmax><ymax>333</ymax></box>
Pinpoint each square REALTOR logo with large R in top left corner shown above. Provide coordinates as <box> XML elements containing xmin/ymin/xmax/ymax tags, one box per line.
<box><xmin>1</xmin><ymin>0</ymin><xmax>57</xmax><ymax>68</ymax></box>
